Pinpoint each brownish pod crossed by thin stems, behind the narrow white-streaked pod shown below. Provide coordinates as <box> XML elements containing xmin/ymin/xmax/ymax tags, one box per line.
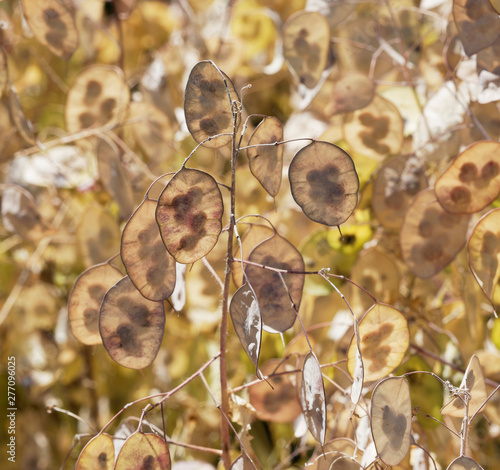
<box><xmin>245</xmin><ymin>234</ymin><xmax>304</xmax><ymax>333</ymax></box>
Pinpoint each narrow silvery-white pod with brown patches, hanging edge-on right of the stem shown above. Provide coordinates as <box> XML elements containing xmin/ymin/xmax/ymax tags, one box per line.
<box><xmin>300</xmin><ymin>351</ymin><xmax>326</xmax><ymax>445</ymax></box>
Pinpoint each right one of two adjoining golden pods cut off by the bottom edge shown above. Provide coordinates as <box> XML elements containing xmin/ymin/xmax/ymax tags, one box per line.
<box><xmin>114</xmin><ymin>431</ymin><xmax>172</xmax><ymax>470</ymax></box>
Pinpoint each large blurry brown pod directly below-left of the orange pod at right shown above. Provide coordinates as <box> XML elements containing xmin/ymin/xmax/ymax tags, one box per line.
<box><xmin>399</xmin><ymin>190</ymin><xmax>469</xmax><ymax>278</ymax></box>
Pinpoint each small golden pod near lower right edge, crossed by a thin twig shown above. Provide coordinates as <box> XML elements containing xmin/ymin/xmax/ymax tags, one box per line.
<box><xmin>441</xmin><ymin>354</ymin><xmax>488</xmax><ymax>419</ymax></box>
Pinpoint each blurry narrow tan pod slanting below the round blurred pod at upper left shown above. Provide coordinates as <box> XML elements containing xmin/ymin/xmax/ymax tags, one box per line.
<box><xmin>96</xmin><ymin>139</ymin><xmax>135</xmax><ymax>220</ymax></box>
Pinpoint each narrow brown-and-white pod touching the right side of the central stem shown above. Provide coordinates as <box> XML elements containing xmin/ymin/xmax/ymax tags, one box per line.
<box><xmin>229</xmin><ymin>284</ymin><xmax>262</xmax><ymax>375</ymax></box>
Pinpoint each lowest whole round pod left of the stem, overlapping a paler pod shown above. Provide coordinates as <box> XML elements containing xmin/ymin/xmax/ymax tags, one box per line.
<box><xmin>99</xmin><ymin>276</ymin><xmax>165</xmax><ymax>369</ymax></box>
